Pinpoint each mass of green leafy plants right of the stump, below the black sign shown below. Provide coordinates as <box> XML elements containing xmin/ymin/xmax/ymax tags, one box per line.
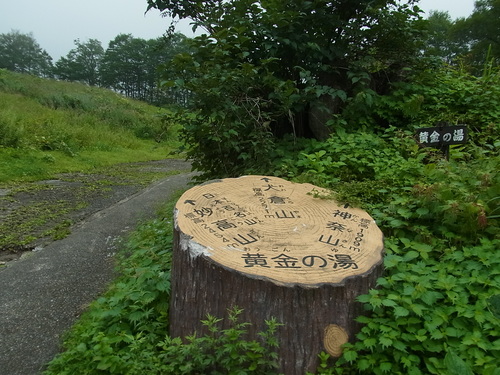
<box><xmin>274</xmin><ymin>129</ymin><xmax>500</xmax><ymax>374</ymax></box>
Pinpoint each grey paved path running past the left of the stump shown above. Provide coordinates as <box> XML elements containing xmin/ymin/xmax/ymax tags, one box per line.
<box><xmin>0</xmin><ymin>173</ymin><xmax>194</xmax><ymax>375</ymax></box>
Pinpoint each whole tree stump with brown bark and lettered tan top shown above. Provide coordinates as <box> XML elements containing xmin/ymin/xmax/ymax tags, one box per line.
<box><xmin>170</xmin><ymin>176</ymin><xmax>383</xmax><ymax>375</ymax></box>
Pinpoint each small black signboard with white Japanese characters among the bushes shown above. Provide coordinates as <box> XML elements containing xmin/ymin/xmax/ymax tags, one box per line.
<box><xmin>417</xmin><ymin>125</ymin><xmax>467</xmax><ymax>148</ymax></box>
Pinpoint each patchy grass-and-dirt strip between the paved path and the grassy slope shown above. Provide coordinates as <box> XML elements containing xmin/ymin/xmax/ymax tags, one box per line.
<box><xmin>0</xmin><ymin>159</ymin><xmax>190</xmax><ymax>267</ymax></box>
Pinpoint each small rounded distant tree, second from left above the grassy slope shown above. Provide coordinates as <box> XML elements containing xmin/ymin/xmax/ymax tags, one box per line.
<box><xmin>54</xmin><ymin>39</ymin><xmax>104</xmax><ymax>86</ymax></box>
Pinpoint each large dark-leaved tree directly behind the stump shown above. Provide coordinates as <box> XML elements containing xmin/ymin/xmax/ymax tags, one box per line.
<box><xmin>148</xmin><ymin>0</ymin><xmax>422</xmax><ymax>177</ymax></box>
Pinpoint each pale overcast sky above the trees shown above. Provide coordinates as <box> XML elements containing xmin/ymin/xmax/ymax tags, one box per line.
<box><xmin>0</xmin><ymin>0</ymin><xmax>474</xmax><ymax>61</ymax></box>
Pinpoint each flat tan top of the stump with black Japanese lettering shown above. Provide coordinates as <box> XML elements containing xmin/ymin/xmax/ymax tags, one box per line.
<box><xmin>175</xmin><ymin>176</ymin><xmax>383</xmax><ymax>287</ymax></box>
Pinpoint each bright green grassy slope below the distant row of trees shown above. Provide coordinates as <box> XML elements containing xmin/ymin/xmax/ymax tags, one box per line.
<box><xmin>0</xmin><ymin>69</ymin><xmax>182</xmax><ymax>182</ymax></box>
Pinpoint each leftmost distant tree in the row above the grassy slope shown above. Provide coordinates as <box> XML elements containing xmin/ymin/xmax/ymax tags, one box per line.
<box><xmin>0</xmin><ymin>30</ymin><xmax>52</xmax><ymax>77</ymax></box>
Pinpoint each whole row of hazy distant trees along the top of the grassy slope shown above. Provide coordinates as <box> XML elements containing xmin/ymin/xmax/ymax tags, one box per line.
<box><xmin>0</xmin><ymin>30</ymin><xmax>190</xmax><ymax>105</ymax></box>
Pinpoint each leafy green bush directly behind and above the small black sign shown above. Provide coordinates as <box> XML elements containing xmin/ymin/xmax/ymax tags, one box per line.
<box><xmin>360</xmin><ymin>66</ymin><xmax>500</xmax><ymax>152</ymax></box>
